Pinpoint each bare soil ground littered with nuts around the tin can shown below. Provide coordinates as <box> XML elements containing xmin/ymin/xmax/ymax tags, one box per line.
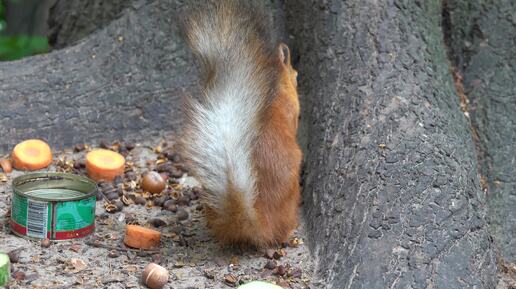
<box><xmin>0</xmin><ymin>140</ymin><xmax>314</xmax><ymax>289</ymax></box>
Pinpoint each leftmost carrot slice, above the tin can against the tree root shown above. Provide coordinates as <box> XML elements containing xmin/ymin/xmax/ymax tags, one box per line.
<box><xmin>11</xmin><ymin>139</ymin><xmax>52</xmax><ymax>171</ymax></box>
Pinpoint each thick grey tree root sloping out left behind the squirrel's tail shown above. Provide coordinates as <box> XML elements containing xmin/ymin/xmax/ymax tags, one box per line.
<box><xmin>0</xmin><ymin>0</ymin><xmax>197</xmax><ymax>153</ymax></box>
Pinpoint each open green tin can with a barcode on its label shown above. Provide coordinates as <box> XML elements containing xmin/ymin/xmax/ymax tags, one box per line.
<box><xmin>10</xmin><ymin>173</ymin><xmax>97</xmax><ymax>240</ymax></box>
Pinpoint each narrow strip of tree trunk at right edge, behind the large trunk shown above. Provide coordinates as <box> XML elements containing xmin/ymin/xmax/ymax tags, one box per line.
<box><xmin>447</xmin><ymin>0</ymin><xmax>516</xmax><ymax>263</ymax></box>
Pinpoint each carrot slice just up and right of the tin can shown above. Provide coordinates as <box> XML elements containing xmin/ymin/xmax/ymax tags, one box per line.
<box><xmin>86</xmin><ymin>149</ymin><xmax>125</xmax><ymax>181</ymax></box>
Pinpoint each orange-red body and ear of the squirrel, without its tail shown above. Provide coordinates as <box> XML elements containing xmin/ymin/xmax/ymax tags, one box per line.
<box><xmin>206</xmin><ymin>44</ymin><xmax>302</xmax><ymax>246</ymax></box>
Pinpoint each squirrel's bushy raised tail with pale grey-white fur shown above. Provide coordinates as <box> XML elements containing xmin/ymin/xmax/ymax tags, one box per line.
<box><xmin>183</xmin><ymin>0</ymin><xmax>278</xmax><ymax>243</ymax></box>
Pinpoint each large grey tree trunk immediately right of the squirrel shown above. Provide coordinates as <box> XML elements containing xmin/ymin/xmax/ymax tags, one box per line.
<box><xmin>287</xmin><ymin>1</ymin><xmax>496</xmax><ymax>288</ymax></box>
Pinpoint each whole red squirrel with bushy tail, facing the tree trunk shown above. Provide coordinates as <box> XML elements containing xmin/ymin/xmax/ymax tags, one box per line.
<box><xmin>182</xmin><ymin>0</ymin><xmax>302</xmax><ymax>247</ymax></box>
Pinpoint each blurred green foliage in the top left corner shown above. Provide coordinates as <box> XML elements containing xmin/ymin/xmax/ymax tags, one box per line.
<box><xmin>0</xmin><ymin>0</ymin><xmax>49</xmax><ymax>61</ymax></box>
